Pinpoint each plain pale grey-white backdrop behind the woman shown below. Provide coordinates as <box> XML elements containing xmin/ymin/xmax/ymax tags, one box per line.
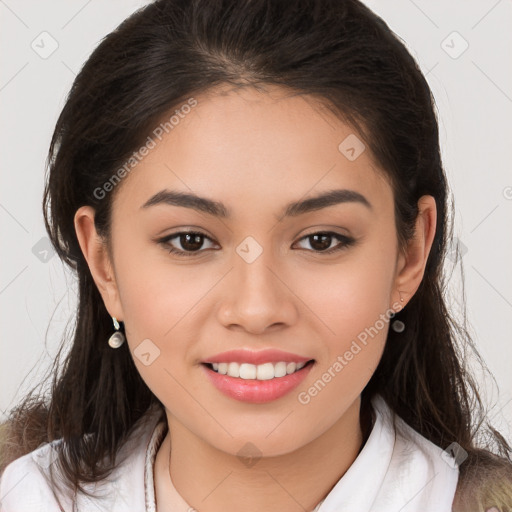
<box><xmin>0</xmin><ymin>0</ymin><xmax>512</xmax><ymax>440</ymax></box>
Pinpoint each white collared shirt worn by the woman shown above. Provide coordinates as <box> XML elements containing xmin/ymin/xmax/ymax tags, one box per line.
<box><xmin>0</xmin><ymin>396</ymin><xmax>459</xmax><ymax>512</ymax></box>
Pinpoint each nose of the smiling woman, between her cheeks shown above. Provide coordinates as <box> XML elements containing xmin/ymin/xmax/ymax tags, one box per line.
<box><xmin>217</xmin><ymin>251</ymin><xmax>298</xmax><ymax>334</ymax></box>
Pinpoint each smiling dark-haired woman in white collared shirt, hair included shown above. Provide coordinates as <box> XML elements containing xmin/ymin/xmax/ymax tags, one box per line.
<box><xmin>0</xmin><ymin>0</ymin><xmax>512</xmax><ymax>512</ymax></box>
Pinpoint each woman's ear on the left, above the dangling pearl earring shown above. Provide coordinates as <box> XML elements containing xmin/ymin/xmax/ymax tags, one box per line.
<box><xmin>74</xmin><ymin>206</ymin><xmax>124</xmax><ymax>321</ymax></box>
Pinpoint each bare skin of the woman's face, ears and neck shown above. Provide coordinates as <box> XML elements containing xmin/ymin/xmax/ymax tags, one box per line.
<box><xmin>75</xmin><ymin>87</ymin><xmax>436</xmax><ymax>512</ymax></box>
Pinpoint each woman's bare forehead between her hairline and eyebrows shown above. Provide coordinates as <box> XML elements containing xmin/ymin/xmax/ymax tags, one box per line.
<box><xmin>114</xmin><ymin>83</ymin><xmax>392</xmax><ymax>220</ymax></box>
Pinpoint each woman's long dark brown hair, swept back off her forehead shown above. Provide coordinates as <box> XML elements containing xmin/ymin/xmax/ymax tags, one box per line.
<box><xmin>2</xmin><ymin>0</ymin><xmax>512</xmax><ymax>510</ymax></box>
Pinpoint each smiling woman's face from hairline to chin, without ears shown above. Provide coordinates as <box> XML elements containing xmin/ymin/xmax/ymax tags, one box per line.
<box><xmin>80</xmin><ymin>89</ymin><xmax>426</xmax><ymax>456</ymax></box>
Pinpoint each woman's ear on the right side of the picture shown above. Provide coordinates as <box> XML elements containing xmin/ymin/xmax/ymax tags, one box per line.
<box><xmin>394</xmin><ymin>195</ymin><xmax>437</xmax><ymax>307</ymax></box>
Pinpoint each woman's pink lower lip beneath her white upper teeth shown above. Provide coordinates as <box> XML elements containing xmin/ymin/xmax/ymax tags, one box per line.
<box><xmin>201</xmin><ymin>363</ymin><xmax>314</xmax><ymax>404</ymax></box>
